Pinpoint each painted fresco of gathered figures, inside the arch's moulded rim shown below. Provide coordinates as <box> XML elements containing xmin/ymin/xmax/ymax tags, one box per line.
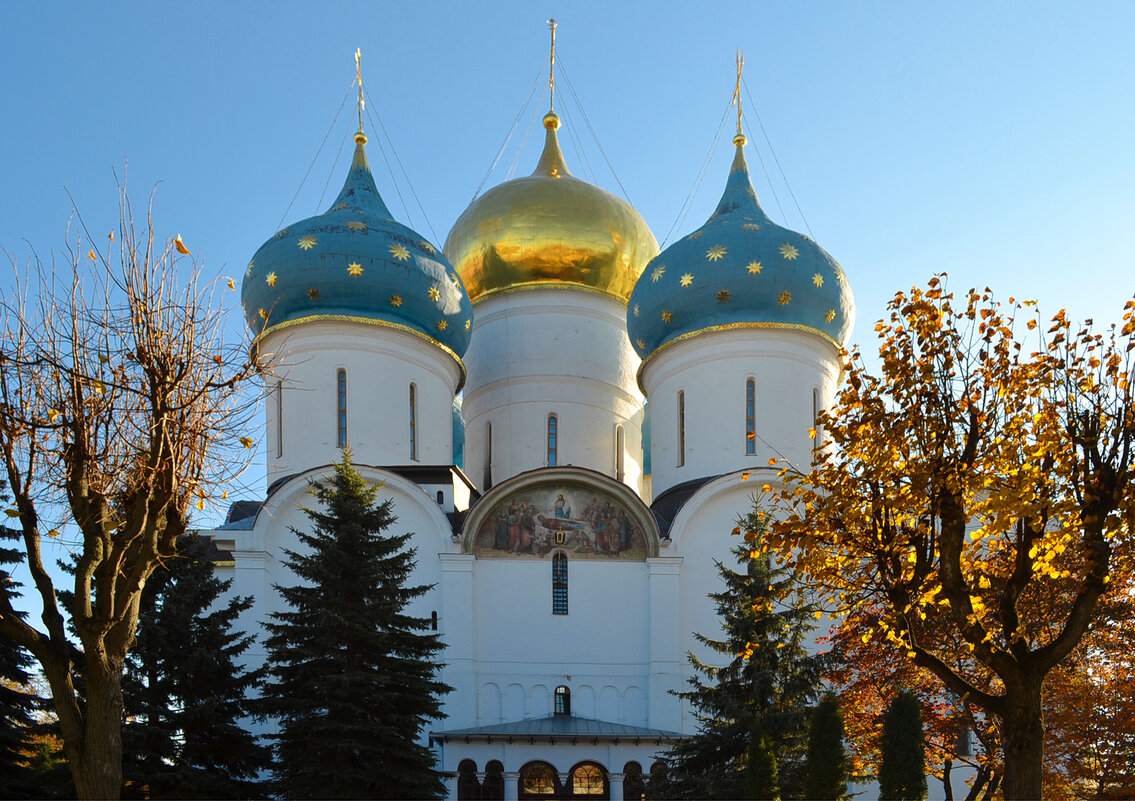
<box><xmin>473</xmin><ymin>486</ymin><xmax>647</xmax><ymax>559</ymax></box>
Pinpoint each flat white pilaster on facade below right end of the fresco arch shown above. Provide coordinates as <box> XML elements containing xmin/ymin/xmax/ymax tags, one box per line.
<box><xmin>646</xmin><ymin>556</ymin><xmax>682</xmax><ymax>732</ymax></box>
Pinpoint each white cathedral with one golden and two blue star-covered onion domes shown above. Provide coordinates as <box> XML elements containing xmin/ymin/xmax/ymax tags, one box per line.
<box><xmin>211</xmin><ymin>53</ymin><xmax>855</xmax><ymax>799</ymax></box>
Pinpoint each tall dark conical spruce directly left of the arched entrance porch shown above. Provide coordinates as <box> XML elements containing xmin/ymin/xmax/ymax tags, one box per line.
<box><xmin>264</xmin><ymin>452</ymin><xmax>449</xmax><ymax>799</ymax></box>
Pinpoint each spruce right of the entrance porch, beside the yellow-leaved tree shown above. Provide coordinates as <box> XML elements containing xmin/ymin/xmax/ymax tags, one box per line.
<box><xmin>650</xmin><ymin>506</ymin><xmax>822</xmax><ymax>799</ymax></box>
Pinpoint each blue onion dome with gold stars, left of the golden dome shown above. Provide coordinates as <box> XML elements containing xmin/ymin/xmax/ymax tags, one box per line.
<box><xmin>241</xmin><ymin>129</ymin><xmax>473</xmax><ymax>359</ymax></box>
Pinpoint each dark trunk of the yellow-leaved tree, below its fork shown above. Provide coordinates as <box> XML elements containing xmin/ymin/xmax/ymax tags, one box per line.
<box><xmin>1001</xmin><ymin>677</ymin><xmax>1044</xmax><ymax>801</ymax></box>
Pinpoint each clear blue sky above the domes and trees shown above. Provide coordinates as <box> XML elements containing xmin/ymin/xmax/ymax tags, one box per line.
<box><xmin>0</xmin><ymin>0</ymin><xmax>1135</xmax><ymax>521</ymax></box>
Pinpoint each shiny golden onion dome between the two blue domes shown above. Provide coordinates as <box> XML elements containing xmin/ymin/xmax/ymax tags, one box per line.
<box><xmin>444</xmin><ymin>112</ymin><xmax>658</xmax><ymax>303</ymax></box>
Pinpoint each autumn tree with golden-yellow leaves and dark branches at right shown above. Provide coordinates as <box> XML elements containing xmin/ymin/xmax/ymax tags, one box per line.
<box><xmin>770</xmin><ymin>277</ymin><xmax>1135</xmax><ymax>801</ymax></box>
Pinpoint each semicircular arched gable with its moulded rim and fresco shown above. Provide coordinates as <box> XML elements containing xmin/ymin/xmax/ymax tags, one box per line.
<box><xmin>462</xmin><ymin>467</ymin><xmax>658</xmax><ymax>562</ymax></box>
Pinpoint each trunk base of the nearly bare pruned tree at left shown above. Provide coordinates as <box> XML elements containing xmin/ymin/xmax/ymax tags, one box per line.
<box><xmin>70</xmin><ymin>661</ymin><xmax>123</xmax><ymax>799</ymax></box>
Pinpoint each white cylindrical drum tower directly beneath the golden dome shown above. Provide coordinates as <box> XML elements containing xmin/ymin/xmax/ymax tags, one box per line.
<box><xmin>463</xmin><ymin>288</ymin><xmax>642</xmax><ymax>490</ymax></box>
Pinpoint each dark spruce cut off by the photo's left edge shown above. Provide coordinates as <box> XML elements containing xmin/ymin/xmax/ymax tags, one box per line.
<box><xmin>0</xmin><ymin>521</ymin><xmax>45</xmax><ymax>799</ymax></box>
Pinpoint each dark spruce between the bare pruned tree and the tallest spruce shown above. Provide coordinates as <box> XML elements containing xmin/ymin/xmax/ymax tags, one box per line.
<box><xmin>123</xmin><ymin>538</ymin><xmax>271</xmax><ymax>799</ymax></box>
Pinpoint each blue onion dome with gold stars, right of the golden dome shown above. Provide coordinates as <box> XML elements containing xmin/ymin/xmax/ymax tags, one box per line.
<box><xmin>627</xmin><ymin>134</ymin><xmax>855</xmax><ymax>359</ymax></box>
